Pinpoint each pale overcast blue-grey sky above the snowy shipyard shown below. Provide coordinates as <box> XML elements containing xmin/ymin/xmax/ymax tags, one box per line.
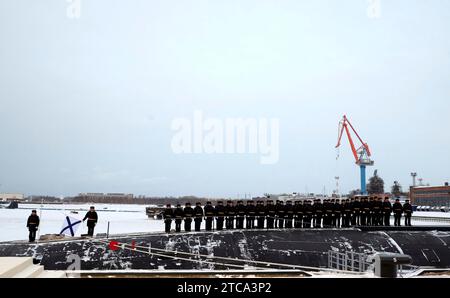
<box><xmin>0</xmin><ymin>0</ymin><xmax>450</xmax><ymax>197</ymax></box>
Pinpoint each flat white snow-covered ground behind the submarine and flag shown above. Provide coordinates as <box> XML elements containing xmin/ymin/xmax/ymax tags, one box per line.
<box><xmin>0</xmin><ymin>204</ymin><xmax>450</xmax><ymax>241</ymax></box>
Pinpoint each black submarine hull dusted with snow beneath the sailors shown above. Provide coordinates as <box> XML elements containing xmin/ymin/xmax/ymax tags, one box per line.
<box><xmin>0</xmin><ymin>226</ymin><xmax>450</xmax><ymax>270</ymax></box>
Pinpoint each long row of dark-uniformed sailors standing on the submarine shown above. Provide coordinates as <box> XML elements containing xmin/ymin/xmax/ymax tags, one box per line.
<box><xmin>163</xmin><ymin>197</ymin><xmax>413</xmax><ymax>233</ymax></box>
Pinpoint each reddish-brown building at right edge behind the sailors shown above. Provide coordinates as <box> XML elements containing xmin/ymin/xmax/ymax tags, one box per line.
<box><xmin>409</xmin><ymin>183</ymin><xmax>450</xmax><ymax>207</ymax></box>
